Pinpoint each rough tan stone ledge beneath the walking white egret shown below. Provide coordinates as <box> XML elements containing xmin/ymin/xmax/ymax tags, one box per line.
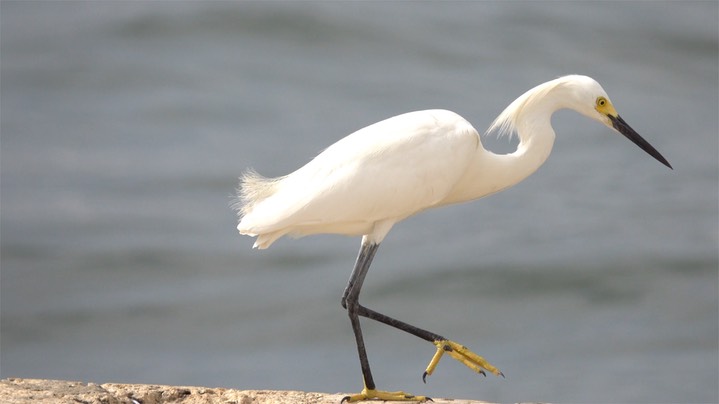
<box><xmin>0</xmin><ymin>378</ymin><xmax>496</xmax><ymax>404</ymax></box>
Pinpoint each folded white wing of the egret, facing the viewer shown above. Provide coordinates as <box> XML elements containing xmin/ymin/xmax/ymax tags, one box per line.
<box><xmin>239</xmin><ymin>110</ymin><xmax>479</xmax><ymax>241</ymax></box>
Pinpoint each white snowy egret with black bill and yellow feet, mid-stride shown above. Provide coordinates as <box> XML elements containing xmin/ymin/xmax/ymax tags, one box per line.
<box><xmin>235</xmin><ymin>75</ymin><xmax>672</xmax><ymax>401</ymax></box>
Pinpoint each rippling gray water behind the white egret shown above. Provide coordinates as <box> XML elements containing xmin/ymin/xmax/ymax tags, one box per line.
<box><xmin>0</xmin><ymin>1</ymin><xmax>719</xmax><ymax>403</ymax></box>
